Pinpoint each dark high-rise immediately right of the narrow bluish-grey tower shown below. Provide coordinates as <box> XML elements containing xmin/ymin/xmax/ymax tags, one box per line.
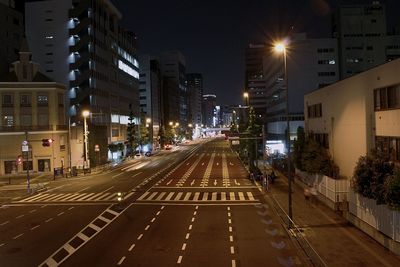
<box><xmin>158</xmin><ymin>51</ymin><xmax>189</xmax><ymax>127</ymax></box>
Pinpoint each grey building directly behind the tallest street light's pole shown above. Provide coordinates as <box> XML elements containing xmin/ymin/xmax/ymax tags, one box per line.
<box><xmin>264</xmin><ymin>33</ymin><xmax>339</xmax><ymax>149</ymax></box>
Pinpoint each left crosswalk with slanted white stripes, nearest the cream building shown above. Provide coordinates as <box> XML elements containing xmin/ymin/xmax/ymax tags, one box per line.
<box><xmin>17</xmin><ymin>192</ymin><xmax>133</xmax><ymax>203</ymax></box>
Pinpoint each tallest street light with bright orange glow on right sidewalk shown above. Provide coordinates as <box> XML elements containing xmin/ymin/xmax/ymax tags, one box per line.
<box><xmin>274</xmin><ymin>41</ymin><xmax>293</xmax><ymax>228</ymax></box>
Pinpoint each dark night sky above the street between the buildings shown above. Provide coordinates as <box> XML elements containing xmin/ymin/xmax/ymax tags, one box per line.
<box><xmin>113</xmin><ymin>0</ymin><xmax>400</xmax><ymax>105</ymax></box>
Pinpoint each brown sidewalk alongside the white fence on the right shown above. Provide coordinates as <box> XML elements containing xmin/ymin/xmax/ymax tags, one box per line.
<box><xmin>266</xmin><ymin>171</ymin><xmax>400</xmax><ymax>266</ymax></box>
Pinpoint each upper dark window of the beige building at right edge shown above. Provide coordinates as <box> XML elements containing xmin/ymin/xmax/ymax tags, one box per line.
<box><xmin>374</xmin><ymin>84</ymin><xmax>400</xmax><ymax>111</ymax></box>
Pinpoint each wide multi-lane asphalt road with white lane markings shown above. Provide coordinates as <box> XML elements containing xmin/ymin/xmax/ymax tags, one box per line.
<box><xmin>0</xmin><ymin>139</ymin><xmax>308</xmax><ymax>267</ymax></box>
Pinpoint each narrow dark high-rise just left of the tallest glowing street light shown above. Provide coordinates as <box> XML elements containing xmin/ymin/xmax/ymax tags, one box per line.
<box><xmin>245</xmin><ymin>44</ymin><xmax>268</xmax><ymax>122</ymax></box>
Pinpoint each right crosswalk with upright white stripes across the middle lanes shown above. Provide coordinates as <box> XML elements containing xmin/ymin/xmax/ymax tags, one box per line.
<box><xmin>137</xmin><ymin>191</ymin><xmax>258</xmax><ymax>202</ymax></box>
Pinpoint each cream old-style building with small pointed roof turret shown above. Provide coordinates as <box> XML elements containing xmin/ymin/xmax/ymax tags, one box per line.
<box><xmin>0</xmin><ymin>46</ymin><xmax>70</xmax><ymax>175</ymax></box>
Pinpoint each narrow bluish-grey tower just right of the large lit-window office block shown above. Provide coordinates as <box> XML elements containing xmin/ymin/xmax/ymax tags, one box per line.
<box><xmin>139</xmin><ymin>55</ymin><xmax>164</xmax><ymax>147</ymax></box>
